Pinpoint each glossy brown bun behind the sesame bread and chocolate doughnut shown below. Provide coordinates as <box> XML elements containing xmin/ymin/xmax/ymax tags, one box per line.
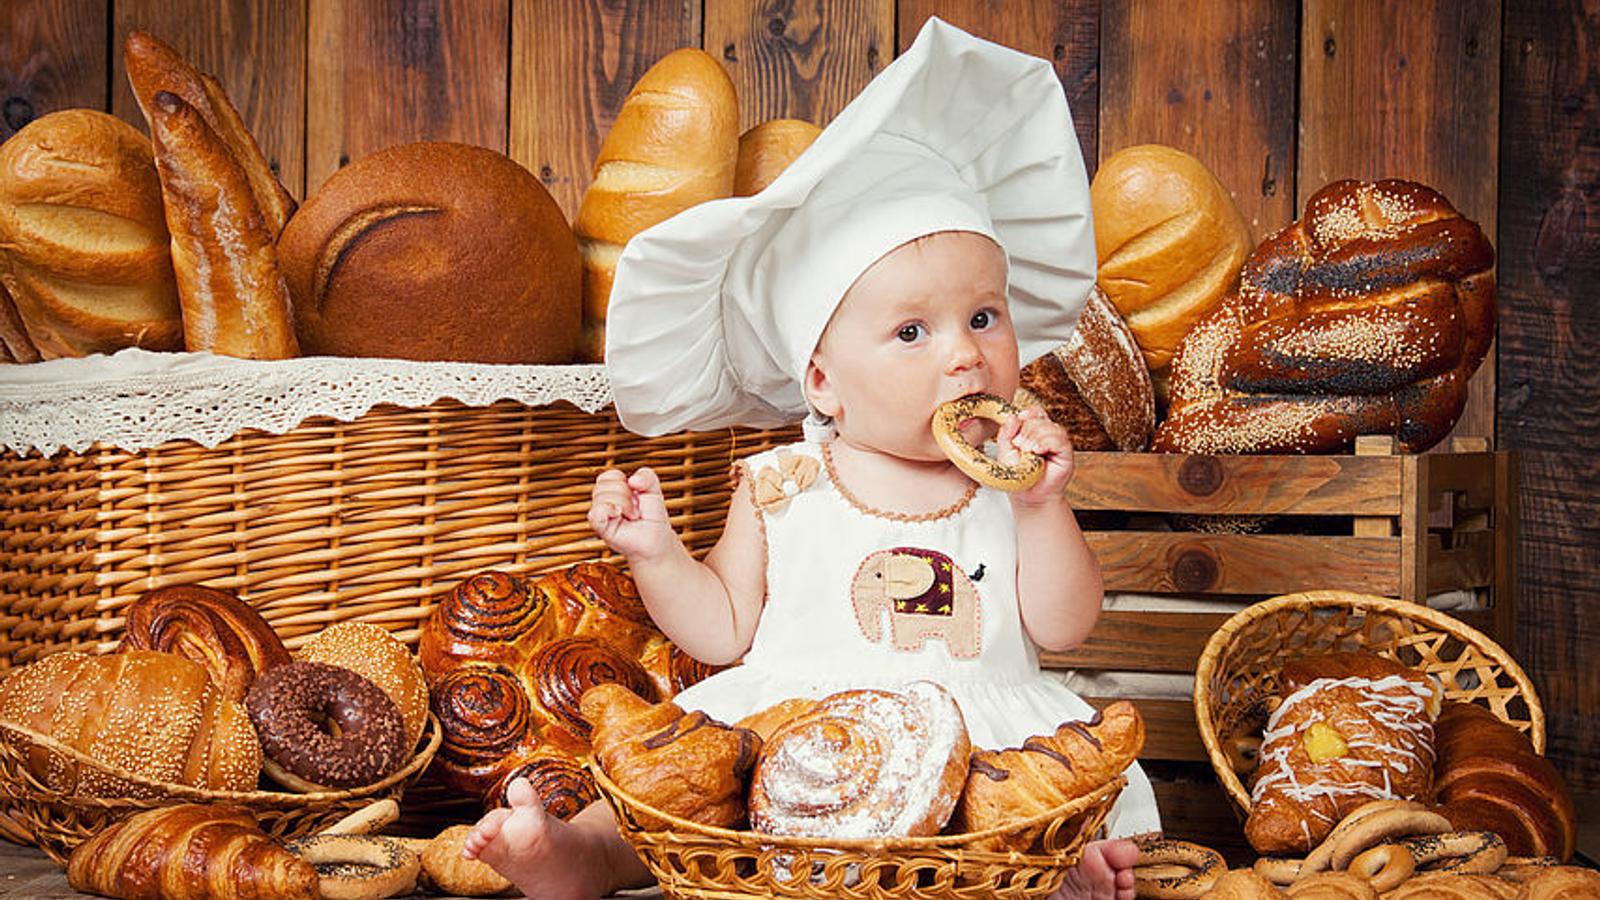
<box><xmin>122</xmin><ymin>585</ymin><xmax>290</xmax><ymax>701</ymax></box>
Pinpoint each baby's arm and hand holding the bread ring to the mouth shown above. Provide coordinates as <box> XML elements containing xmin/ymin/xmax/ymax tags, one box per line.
<box><xmin>998</xmin><ymin>407</ymin><xmax>1106</xmax><ymax>650</ymax></box>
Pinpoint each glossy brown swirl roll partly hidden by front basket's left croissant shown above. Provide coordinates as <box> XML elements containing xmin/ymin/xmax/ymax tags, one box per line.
<box><xmin>523</xmin><ymin>637</ymin><xmax>656</xmax><ymax>753</ymax></box>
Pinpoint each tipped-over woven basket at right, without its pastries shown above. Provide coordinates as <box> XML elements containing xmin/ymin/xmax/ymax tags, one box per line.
<box><xmin>1195</xmin><ymin>591</ymin><xmax>1544</xmax><ymax>815</ymax></box>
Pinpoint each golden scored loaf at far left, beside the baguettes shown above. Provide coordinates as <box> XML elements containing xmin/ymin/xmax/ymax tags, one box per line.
<box><xmin>0</xmin><ymin>109</ymin><xmax>182</xmax><ymax>355</ymax></box>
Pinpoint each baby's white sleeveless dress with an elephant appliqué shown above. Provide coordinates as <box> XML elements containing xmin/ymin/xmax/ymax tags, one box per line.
<box><xmin>674</xmin><ymin>444</ymin><xmax>1160</xmax><ymax>836</ymax></box>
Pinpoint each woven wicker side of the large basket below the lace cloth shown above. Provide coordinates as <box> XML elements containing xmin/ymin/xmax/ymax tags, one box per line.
<box><xmin>0</xmin><ymin>402</ymin><xmax>797</xmax><ymax>671</ymax></box>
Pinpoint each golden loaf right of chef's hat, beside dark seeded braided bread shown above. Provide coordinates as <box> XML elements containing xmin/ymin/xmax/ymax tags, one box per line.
<box><xmin>1090</xmin><ymin>144</ymin><xmax>1251</xmax><ymax>383</ymax></box>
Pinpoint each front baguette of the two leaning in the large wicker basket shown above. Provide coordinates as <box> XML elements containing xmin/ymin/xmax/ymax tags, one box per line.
<box><xmin>147</xmin><ymin>91</ymin><xmax>299</xmax><ymax>359</ymax></box>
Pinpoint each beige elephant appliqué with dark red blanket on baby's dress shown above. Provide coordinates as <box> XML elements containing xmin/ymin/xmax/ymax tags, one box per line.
<box><xmin>850</xmin><ymin>546</ymin><xmax>981</xmax><ymax>658</ymax></box>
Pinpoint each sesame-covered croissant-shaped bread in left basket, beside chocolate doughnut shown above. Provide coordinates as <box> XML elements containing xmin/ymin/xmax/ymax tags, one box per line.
<box><xmin>0</xmin><ymin>650</ymin><xmax>261</xmax><ymax>796</ymax></box>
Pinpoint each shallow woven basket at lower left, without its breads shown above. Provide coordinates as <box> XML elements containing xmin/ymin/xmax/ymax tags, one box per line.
<box><xmin>0</xmin><ymin>714</ymin><xmax>443</xmax><ymax>865</ymax></box>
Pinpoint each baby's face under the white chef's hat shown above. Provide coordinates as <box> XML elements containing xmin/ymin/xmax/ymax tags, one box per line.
<box><xmin>806</xmin><ymin>232</ymin><xmax>1018</xmax><ymax>460</ymax></box>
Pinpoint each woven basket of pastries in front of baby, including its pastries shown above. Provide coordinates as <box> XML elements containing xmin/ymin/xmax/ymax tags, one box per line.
<box><xmin>582</xmin><ymin>682</ymin><xmax>1144</xmax><ymax>898</ymax></box>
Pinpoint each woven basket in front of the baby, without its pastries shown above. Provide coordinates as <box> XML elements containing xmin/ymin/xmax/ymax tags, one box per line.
<box><xmin>589</xmin><ymin>764</ymin><xmax>1128</xmax><ymax>900</ymax></box>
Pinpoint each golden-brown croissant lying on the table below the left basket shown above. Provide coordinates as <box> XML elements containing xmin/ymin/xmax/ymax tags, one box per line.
<box><xmin>67</xmin><ymin>804</ymin><xmax>320</xmax><ymax>900</ymax></box>
